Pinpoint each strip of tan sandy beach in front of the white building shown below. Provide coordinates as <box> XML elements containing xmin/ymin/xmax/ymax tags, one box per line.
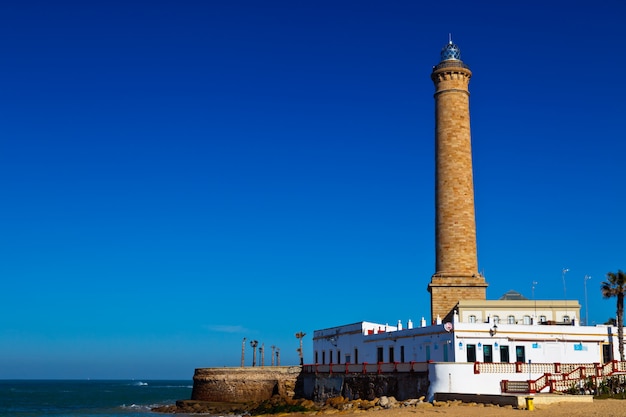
<box><xmin>290</xmin><ymin>400</ymin><xmax>626</xmax><ymax>417</ymax></box>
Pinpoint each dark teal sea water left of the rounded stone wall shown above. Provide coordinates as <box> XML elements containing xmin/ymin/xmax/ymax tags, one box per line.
<box><xmin>0</xmin><ymin>380</ymin><xmax>193</xmax><ymax>417</ymax></box>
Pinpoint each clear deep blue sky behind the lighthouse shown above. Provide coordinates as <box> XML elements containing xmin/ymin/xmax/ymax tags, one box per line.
<box><xmin>0</xmin><ymin>0</ymin><xmax>626</xmax><ymax>379</ymax></box>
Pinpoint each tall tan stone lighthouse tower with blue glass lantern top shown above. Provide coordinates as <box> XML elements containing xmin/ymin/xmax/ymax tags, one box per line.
<box><xmin>428</xmin><ymin>40</ymin><xmax>487</xmax><ymax>321</ymax></box>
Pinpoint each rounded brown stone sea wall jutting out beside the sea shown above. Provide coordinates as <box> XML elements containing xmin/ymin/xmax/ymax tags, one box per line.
<box><xmin>191</xmin><ymin>366</ymin><xmax>301</xmax><ymax>403</ymax></box>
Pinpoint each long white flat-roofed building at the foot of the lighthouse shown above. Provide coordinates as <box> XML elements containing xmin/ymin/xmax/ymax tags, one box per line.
<box><xmin>313</xmin><ymin>299</ymin><xmax>626</xmax><ymax>399</ymax></box>
